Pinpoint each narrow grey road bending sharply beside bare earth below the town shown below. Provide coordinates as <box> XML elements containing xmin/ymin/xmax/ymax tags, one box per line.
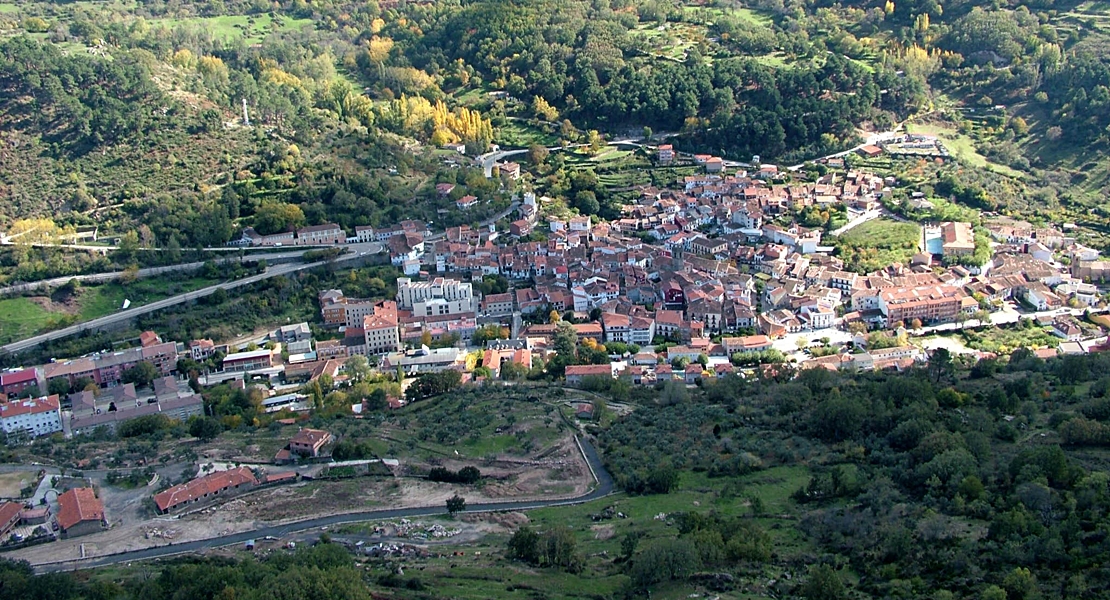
<box><xmin>34</xmin><ymin>438</ymin><xmax>613</xmax><ymax>573</ymax></box>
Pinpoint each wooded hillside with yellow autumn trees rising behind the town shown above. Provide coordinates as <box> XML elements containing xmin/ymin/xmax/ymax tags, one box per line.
<box><xmin>0</xmin><ymin>0</ymin><xmax>1110</xmax><ymax>248</ymax></box>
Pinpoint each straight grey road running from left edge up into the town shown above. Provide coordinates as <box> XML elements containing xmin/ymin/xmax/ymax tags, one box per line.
<box><xmin>0</xmin><ymin>242</ymin><xmax>383</xmax><ymax>353</ymax></box>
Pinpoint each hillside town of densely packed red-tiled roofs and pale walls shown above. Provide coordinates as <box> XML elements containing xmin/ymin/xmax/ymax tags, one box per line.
<box><xmin>0</xmin><ymin>156</ymin><xmax>1110</xmax><ymax>421</ymax></box>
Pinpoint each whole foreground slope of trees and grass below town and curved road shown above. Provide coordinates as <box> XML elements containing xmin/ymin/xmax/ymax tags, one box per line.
<box><xmin>0</xmin><ymin>349</ymin><xmax>1110</xmax><ymax>600</ymax></box>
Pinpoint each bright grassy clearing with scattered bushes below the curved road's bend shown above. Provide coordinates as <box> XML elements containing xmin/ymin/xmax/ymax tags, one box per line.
<box><xmin>355</xmin><ymin>467</ymin><xmax>815</xmax><ymax>600</ymax></box>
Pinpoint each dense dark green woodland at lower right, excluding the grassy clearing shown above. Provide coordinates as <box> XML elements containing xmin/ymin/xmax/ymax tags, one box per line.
<box><xmin>599</xmin><ymin>349</ymin><xmax>1110</xmax><ymax>599</ymax></box>
